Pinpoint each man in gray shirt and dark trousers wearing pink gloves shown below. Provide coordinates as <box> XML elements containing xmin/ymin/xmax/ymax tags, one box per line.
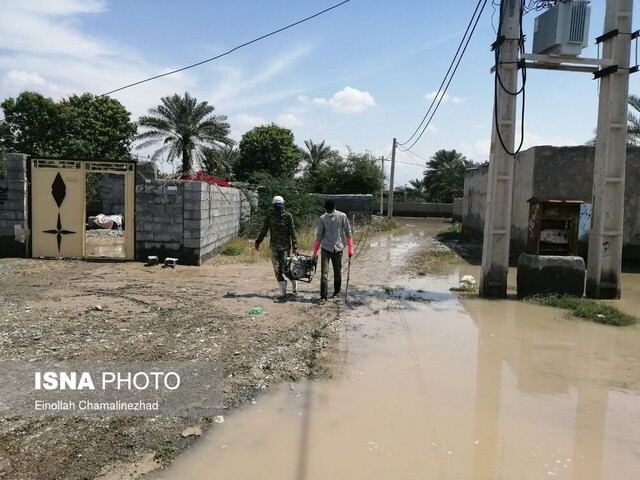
<box><xmin>313</xmin><ymin>200</ymin><xmax>353</xmax><ymax>301</ymax></box>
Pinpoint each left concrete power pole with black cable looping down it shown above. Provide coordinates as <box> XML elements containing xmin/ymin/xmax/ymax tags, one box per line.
<box><xmin>479</xmin><ymin>0</ymin><xmax>521</xmax><ymax>298</ymax></box>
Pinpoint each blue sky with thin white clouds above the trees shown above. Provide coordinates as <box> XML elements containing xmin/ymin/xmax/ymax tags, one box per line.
<box><xmin>0</xmin><ymin>0</ymin><xmax>640</xmax><ymax>185</ymax></box>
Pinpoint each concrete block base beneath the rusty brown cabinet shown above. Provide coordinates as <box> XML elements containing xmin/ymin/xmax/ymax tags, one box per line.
<box><xmin>516</xmin><ymin>253</ymin><xmax>585</xmax><ymax>298</ymax></box>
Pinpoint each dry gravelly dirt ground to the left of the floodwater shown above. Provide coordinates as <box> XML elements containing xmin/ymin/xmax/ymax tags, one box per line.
<box><xmin>0</xmin><ymin>221</ymin><xmax>447</xmax><ymax>479</ymax></box>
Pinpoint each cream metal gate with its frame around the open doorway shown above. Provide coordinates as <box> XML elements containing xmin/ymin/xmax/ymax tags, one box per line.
<box><xmin>30</xmin><ymin>158</ymin><xmax>135</xmax><ymax>260</ymax></box>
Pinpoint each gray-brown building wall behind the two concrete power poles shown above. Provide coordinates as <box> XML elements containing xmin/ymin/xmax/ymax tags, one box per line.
<box><xmin>462</xmin><ymin>146</ymin><xmax>640</xmax><ymax>260</ymax></box>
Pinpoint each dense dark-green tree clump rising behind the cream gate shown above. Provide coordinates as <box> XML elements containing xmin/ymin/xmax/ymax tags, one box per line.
<box><xmin>0</xmin><ymin>92</ymin><xmax>136</xmax><ymax>159</ymax></box>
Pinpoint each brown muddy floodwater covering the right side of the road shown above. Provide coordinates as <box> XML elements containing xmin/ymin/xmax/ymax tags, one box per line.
<box><xmin>153</xmin><ymin>223</ymin><xmax>640</xmax><ymax>480</ymax></box>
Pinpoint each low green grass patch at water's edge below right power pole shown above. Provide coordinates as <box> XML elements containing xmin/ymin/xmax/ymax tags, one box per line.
<box><xmin>527</xmin><ymin>295</ymin><xmax>638</xmax><ymax>327</ymax></box>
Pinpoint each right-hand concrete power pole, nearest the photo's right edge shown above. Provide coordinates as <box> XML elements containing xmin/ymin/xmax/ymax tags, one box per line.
<box><xmin>586</xmin><ymin>0</ymin><xmax>633</xmax><ymax>298</ymax></box>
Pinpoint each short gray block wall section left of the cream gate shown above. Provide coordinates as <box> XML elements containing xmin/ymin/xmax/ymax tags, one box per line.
<box><xmin>0</xmin><ymin>153</ymin><xmax>29</xmax><ymax>258</ymax></box>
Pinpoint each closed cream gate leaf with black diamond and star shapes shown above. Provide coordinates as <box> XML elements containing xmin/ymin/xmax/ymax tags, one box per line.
<box><xmin>31</xmin><ymin>159</ymin><xmax>85</xmax><ymax>258</ymax></box>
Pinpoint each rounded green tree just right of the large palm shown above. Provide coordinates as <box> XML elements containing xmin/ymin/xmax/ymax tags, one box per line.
<box><xmin>235</xmin><ymin>123</ymin><xmax>300</xmax><ymax>181</ymax></box>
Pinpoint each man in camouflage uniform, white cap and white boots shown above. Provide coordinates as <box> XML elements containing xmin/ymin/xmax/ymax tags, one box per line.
<box><xmin>255</xmin><ymin>195</ymin><xmax>298</xmax><ymax>299</ymax></box>
